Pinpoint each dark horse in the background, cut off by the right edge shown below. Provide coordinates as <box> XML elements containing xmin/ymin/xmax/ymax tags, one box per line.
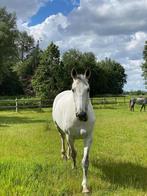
<box><xmin>129</xmin><ymin>97</ymin><xmax>147</xmax><ymax>112</ymax></box>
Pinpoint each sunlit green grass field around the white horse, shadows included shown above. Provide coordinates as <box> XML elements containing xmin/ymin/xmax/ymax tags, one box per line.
<box><xmin>0</xmin><ymin>104</ymin><xmax>147</xmax><ymax>196</ymax></box>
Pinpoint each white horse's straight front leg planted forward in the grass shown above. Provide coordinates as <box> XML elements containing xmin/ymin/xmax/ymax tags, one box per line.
<box><xmin>82</xmin><ymin>137</ymin><xmax>92</xmax><ymax>193</ymax></box>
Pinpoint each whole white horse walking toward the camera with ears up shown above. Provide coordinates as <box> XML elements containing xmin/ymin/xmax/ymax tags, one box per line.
<box><xmin>53</xmin><ymin>69</ymin><xmax>95</xmax><ymax>193</ymax></box>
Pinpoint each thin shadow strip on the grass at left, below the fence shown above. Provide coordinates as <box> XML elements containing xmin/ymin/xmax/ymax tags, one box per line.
<box><xmin>0</xmin><ymin>116</ymin><xmax>47</xmax><ymax>127</ymax></box>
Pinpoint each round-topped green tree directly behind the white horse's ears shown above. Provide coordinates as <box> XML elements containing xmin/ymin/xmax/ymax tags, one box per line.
<box><xmin>62</xmin><ymin>49</ymin><xmax>114</xmax><ymax>96</ymax></box>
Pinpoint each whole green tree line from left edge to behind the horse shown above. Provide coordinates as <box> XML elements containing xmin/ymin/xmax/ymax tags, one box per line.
<box><xmin>0</xmin><ymin>8</ymin><xmax>127</xmax><ymax>98</ymax></box>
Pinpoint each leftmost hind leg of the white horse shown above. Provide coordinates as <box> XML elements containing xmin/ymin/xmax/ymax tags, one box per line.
<box><xmin>56</xmin><ymin>123</ymin><xmax>67</xmax><ymax>160</ymax></box>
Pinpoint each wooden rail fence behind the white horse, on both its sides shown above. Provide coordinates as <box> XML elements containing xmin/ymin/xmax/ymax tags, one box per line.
<box><xmin>0</xmin><ymin>96</ymin><xmax>128</xmax><ymax>112</ymax></box>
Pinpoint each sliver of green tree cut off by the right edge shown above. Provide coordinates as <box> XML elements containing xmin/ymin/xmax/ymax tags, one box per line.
<box><xmin>141</xmin><ymin>41</ymin><xmax>147</xmax><ymax>88</ymax></box>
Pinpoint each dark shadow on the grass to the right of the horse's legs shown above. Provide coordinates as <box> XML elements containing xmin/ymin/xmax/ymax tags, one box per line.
<box><xmin>92</xmin><ymin>159</ymin><xmax>147</xmax><ymax>191</ymax></box>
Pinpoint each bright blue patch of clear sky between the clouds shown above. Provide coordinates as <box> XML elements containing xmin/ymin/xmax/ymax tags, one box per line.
<box><xmin>28</xmin><ymin>0</ymin><xmax>80</xmax><ymax>26</ymax></box>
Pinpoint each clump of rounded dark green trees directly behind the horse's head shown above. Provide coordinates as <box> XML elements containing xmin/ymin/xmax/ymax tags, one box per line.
<box><xmin>62</xmin><ymin>49</ymin><xmax>126</xmax><ymax>96</ymax></box>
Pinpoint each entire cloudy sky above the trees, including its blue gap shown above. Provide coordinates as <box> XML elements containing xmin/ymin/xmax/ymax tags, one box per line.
<box><xmin>0</xmin><ymin>0</ymin><xmax>147</xmax><ymax>91</ymax></box>
